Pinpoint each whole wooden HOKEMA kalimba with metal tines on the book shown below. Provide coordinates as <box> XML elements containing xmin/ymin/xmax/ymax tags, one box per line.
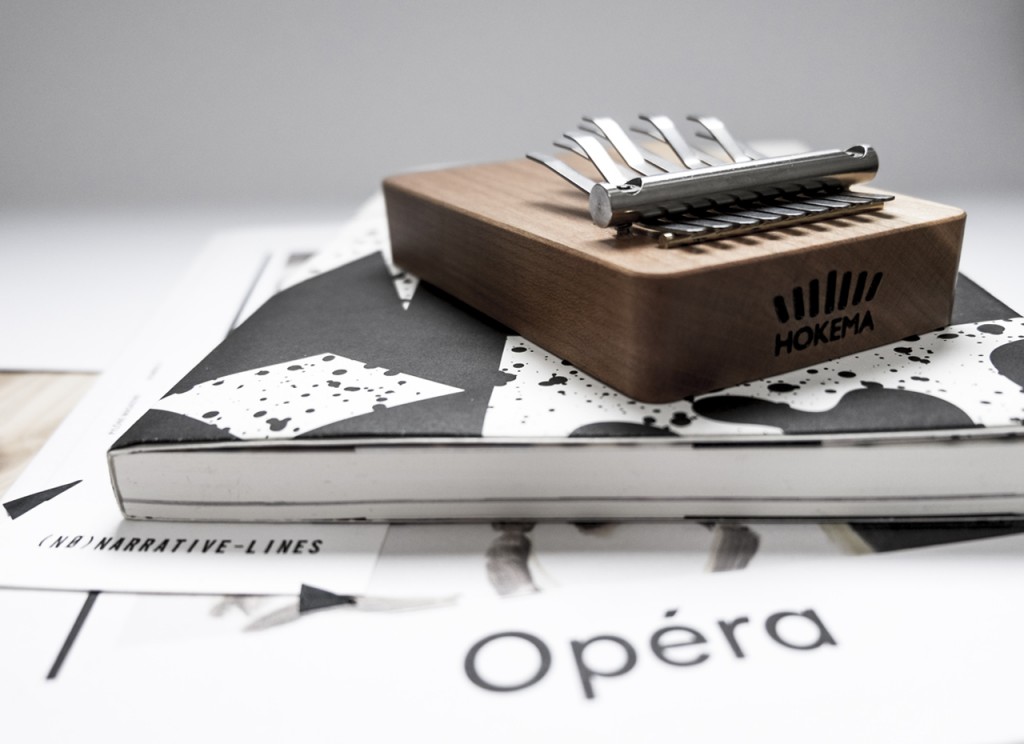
<box><xmin>384</xmin><ymin>116</ymin><xmax>966</xmax><ymax>402</ymax></box>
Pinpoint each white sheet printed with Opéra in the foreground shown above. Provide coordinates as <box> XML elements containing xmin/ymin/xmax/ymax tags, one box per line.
<box><xmin>8</xmin><ymin>536</ymin><xmax>1024</xmax><ymax>744</ymax></box>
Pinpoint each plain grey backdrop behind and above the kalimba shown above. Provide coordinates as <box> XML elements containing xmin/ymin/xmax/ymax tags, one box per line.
<box><xmin>0</xmin><ymin>0</ymin><xmax>1024</xmax><ymax>209</ymax></box>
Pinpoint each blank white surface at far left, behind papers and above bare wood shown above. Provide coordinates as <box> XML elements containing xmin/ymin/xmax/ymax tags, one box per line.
<box><xmin>0</xmin><ymin>209</ymin><xmax>350</xmax><ymax>371</ymax></box>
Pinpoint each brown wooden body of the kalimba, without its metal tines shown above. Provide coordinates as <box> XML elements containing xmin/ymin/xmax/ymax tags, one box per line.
<box><xmin>384</xmin><ymin>160</ymin><xmax>965</xmax><ymax>402</ymax></box>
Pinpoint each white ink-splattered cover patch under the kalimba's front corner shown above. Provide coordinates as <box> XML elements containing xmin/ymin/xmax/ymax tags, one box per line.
<box><xmin>483</xmin><ymin>318</ymin><xmax>1024</xmax><ymax>437</ymax></box>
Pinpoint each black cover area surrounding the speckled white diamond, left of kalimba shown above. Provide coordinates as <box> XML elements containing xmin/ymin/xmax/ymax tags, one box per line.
<box><xmin>113</xmin><ymin>254</ymin><xmax>511</xmax><ymax>449</ymax></box>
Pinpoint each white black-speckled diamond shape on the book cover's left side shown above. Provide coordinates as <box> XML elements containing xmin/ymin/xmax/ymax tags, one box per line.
<box><xmin>154</xmin><ymin>354</ymin><xmax>462</xmax><ymax>439</ymax></box>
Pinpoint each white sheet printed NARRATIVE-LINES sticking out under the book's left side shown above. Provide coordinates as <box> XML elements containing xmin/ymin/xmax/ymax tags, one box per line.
<box><xmin>0</xmin><ymin>221</ymin><xmax>386</xmax><ymax>594</ymax></box>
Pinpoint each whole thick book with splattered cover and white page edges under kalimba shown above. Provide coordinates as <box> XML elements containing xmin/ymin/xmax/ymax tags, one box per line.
<box><xmin>108</xmin><ymin>197</ymin><xmax>1024</xmax><ymax>521</ymax></box>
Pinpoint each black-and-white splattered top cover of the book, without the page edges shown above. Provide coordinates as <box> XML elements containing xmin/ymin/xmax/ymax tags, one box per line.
<box><xmin>111</xmin><ymin>199</ymin><xmax>1024</xmax><ymax>516</ymax></box>
